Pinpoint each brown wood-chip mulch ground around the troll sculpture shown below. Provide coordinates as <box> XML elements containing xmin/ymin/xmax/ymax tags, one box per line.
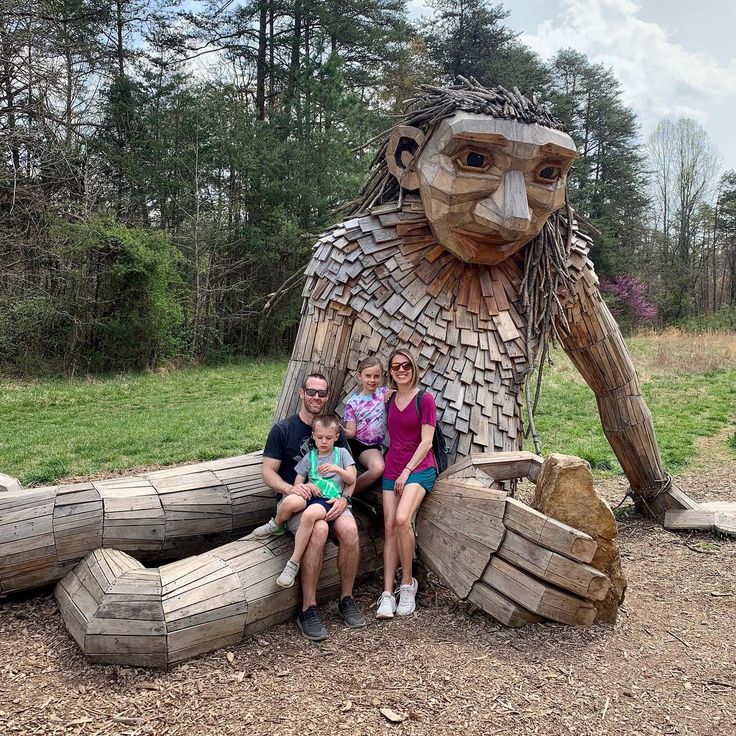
<box><xmin>0</xmin><ymin>462</ymin><xmax>736</xmax><ymax>736</ymax></box>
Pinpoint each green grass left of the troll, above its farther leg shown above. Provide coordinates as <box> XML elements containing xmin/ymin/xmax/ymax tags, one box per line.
<box><xmin>0</xmin><ymin>360</ymin><xmax>286</xmax><ymax>485</ymax></box>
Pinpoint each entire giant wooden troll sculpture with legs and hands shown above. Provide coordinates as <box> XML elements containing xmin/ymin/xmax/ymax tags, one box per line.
<box><xmin>0</xmin><ymin>81</ymin><xmax>720</xmax><ymax>666</ymax></box>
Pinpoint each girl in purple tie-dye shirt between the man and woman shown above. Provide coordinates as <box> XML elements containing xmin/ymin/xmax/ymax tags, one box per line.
<box><xmin>344</xmin><ymin>357</ymin><xmax>390</xmax><ymax>493</ymax></box>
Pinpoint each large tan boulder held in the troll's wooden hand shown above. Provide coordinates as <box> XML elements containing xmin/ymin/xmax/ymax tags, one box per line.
<box><xmin>533</xmin><ymin>454</ymin><xmax>626</xmax><ymax>624</ymax></box>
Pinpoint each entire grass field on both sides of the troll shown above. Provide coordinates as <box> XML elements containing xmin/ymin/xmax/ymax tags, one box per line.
<box><xmin>0</xmin><ymin>333</ymin><xmax>736</xmax><ymax>485</ymax></box>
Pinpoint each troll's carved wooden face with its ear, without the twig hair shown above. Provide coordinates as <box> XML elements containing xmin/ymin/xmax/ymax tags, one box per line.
<box><xmin>387</xmin><ymin>112</ymin><xmax>577</xmax><ymax>265</ymax></box>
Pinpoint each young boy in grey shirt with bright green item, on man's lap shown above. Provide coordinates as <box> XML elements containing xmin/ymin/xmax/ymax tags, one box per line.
<box><xmin>253</xmin><ymin>414</ymin><xmax>356</xmax><ymax>588</ymax></box>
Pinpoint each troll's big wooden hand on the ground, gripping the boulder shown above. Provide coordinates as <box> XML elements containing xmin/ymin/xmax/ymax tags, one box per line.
<box><xmin>416</xmin><ymin>452</ymin><xmax>611</xmax><ymax>626</ymax></box>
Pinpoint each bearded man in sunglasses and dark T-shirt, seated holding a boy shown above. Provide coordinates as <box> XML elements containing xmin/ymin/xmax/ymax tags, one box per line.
<box><xmin>262</xmin><ymin>373</ymin><xmax>366</xmax><ymax>641</ymax></box>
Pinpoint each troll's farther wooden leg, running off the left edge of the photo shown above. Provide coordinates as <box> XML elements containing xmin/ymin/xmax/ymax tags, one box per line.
<box><xmin>0</xmin><ymin>453</ymin><xmax>275</xmax><ymax>596</ymax></box>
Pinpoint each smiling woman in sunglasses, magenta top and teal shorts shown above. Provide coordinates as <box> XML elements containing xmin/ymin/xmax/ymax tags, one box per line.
<box><xmin>376</xmin><ymin>350</ymin><xmax>437</xmax><ymax>619</ymax></box>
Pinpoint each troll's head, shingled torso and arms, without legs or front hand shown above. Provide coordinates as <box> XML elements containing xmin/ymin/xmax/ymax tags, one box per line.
<box><xmin>276</xmin><ymin>80</ymin><xmax>680</xmax><ymax>516</ymax></box>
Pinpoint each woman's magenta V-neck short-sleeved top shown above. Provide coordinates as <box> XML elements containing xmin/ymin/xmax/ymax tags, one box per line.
<box><xmin>383</xmin><ymin>392</ymin><xmax>437</xmax><ymax>480</ymax></box>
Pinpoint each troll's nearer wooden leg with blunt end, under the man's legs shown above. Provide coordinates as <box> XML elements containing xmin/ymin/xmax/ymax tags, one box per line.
<box><xmin>55</xmin><ymin>508</ymin><xmax>383</xmax><ymax>667</ymax></box>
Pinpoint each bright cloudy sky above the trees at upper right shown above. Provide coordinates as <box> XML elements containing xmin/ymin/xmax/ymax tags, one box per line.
<box><xmin>409</xmin><ymin>0</ymin><xmax>736</xmax><ymax>169</ymax></box>
